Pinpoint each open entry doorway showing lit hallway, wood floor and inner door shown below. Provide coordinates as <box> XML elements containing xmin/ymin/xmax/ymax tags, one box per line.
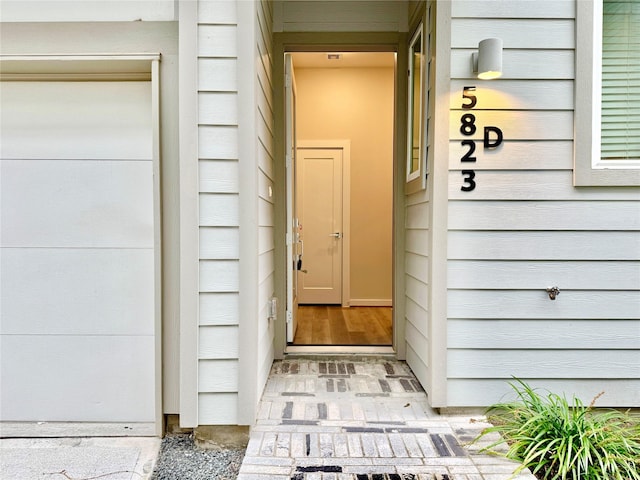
<box><xmin>286</xmin><ymin>52</ymin><xmax>396</xmax><ymax>351</ymax></box>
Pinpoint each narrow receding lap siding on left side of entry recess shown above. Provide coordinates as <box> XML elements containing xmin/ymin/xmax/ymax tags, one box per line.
<box><xmin>256</xmin><ymin>0</ymin><xmax>275</xmax><ymax>402</ymax></box>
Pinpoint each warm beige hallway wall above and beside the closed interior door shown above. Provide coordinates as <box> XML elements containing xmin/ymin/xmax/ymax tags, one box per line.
<box><xmin>295</xmin><ymin>68</ymin><xmax>394</xmax><ymax>304</ymax></box>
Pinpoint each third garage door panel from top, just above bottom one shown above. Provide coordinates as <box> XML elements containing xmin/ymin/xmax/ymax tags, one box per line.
<box><xmin>0</xmin><ymin>248</ymin><xmax>154</xmax><ymax>335</ymax></box>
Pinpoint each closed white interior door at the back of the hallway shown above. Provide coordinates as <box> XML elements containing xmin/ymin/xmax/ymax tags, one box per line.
<box><xmin>296</xmin><ymin>148</ymin><xmax>343</xmax><ymax>304</ymax></box>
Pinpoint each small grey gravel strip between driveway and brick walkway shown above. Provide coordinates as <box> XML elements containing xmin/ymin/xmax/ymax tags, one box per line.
<box><xmin>151</xmin><ymin>434</ymin><xmax>244</xmax><ymax>480</ymax></box>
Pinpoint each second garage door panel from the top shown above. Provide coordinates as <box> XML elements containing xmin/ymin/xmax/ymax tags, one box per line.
<box><xmin>0</xmin><ymin>160</ymin><xmax>154</xmax><ymax>248</ymax></box>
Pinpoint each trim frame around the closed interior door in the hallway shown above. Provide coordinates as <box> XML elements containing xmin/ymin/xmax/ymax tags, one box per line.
<box><xmin>297</xmin><ymin>140</ymin><xmax>351</xmax><ymax>307</ymax></box>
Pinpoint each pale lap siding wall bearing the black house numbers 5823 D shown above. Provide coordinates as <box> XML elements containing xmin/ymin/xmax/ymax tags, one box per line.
<box><xmin>447</xmin><ymin>0</ymin><xmax>640</xmax><ymax>406</ymax></box>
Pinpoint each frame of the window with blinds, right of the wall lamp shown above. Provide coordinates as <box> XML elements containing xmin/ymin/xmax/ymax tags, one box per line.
<box><xmin>573</xmin><ymin>0</ymin><xmax>640</xmax><ymax>186</ymax></box>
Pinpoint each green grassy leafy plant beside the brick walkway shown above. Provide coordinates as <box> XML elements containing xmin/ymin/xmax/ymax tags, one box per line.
<box><xmin>474</xmin><ymin>379</ymin><xmax>640</xmax><ymax>480</ymax></box>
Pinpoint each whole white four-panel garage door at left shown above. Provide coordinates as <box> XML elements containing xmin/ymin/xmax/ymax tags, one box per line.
<box><xmin>0</xmin><ymin>81</ymin><xmax>155</xmax><ymax>422</ymax></box>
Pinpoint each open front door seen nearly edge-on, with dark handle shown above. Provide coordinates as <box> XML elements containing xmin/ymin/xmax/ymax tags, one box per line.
<box><xmin>285</xmin><ymin>54</ymin><xmax>301</xmax><ymax>343</ymax></box>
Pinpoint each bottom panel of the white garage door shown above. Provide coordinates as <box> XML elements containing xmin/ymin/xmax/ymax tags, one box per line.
<box><xmin>0</xmin><ymin>335</ymin><xmax>155</xmax><ymax>422</ymax></box>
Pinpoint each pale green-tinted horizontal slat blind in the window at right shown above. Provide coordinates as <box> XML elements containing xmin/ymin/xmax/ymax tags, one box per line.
<box><xmin>601</xmin><ymin>0</ymin><xmax>640</xmax><ymax>162</ymax></box>
